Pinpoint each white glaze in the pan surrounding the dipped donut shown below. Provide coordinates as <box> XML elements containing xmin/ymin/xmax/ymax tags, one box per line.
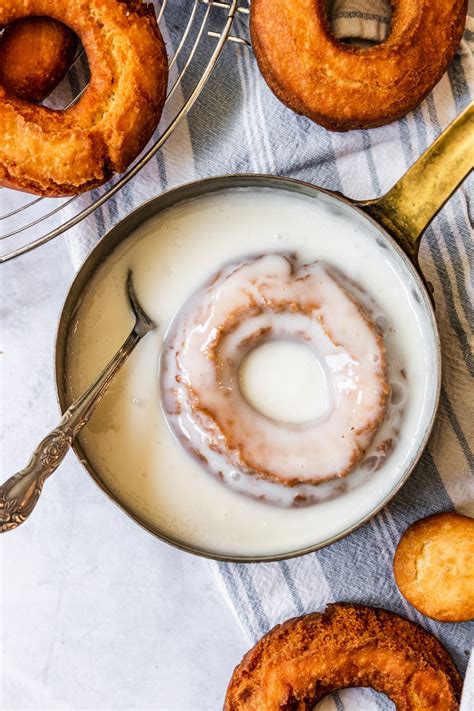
<box><xmin>68</xmin><ymin>189</ymin><xmax>437</xmax><ymax>556</ymax></box>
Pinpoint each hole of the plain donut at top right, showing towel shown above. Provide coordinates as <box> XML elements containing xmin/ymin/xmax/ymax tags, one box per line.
<box><xmin>326</xmin><ymin>0</ymin><xmax>392</xmax><ymax>49</ymax></box>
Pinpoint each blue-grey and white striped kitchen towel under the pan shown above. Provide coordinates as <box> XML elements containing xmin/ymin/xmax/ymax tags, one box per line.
<box><xmin>67</xmin><ymin>0</ymin><xmax>474</xmax><ymax>711</ymax></box>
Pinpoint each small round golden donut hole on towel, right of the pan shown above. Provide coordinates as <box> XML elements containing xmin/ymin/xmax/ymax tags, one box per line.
<box><xmin>393</xmin><ymin>513</ymin><xmax>474</xmax><ymax>622</ymax></box>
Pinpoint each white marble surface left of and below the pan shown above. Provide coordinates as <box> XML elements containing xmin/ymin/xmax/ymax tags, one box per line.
<box><xmin>0</xmin><ymin>238</ymin><xmax>248</xmax><ymax>711</ymax></box>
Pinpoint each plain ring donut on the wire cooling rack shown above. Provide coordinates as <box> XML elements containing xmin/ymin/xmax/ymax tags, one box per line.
<box><xmin>0</xmin><ymin>0</ymin><xmax>168</xmax><ymax>196</ymax></box>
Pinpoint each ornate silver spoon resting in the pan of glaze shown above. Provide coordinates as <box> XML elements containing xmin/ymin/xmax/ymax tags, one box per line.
<box><xmin>0</xmin><ymin>271</ymin><xmax>155</xmax><ymax>533</ymax></box>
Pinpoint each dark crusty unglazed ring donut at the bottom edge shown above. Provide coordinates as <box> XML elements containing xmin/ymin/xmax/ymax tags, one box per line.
<box><xmin>224</xmin><ymin>603</ymin><xmax>462</xmax><ymax>711</ymax></box>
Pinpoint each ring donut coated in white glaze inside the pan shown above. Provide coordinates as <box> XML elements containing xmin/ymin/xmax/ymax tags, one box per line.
<box><xmin>160</xmin><ymin>254</ymin><xmax>389</xmax><ymax>500</ymax></box>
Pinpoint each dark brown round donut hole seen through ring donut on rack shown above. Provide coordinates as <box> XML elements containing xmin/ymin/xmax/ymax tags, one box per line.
<box><xmin>0</xmin><ymin>17</ymin><xmax>77</xmax><ymax>103</ymax></box>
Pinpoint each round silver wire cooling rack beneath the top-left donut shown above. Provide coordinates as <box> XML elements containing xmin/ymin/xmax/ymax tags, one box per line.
<box><xmin>0</xmin><ymin>0</ymin><xmax>249</xmax><ymax>263</ymax></box>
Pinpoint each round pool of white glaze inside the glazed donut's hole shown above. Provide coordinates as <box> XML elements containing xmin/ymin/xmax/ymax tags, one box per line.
<box><xmin>238</xmin><ymin>340</ymin><xmax>330</xmax><ymax>425</ymax></box>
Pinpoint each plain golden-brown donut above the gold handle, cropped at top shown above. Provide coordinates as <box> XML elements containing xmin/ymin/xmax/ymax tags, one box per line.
<box><xmin>250</xmin><ymin>0</ymin><xmax>467</xmax><ymax>131</ymax></box>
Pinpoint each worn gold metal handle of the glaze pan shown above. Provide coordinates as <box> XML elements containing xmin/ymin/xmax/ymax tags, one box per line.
<box><xmin>359</xmin><ymin>102</ymin><xmax>474</xmax><ymax>263</ymax></box>
